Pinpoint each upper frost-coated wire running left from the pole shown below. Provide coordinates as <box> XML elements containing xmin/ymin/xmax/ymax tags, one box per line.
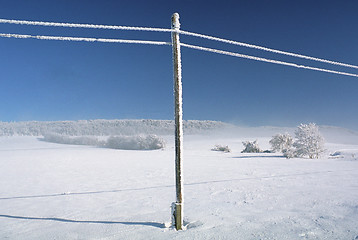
<box><xmin>0</xmin><ymin>19</ymin><xmax>172</xmax><ymax>32</ymax></box>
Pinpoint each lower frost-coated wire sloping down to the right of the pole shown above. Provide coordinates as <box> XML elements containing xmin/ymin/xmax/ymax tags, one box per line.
<box><xmin>180</xmin><ymin>43</ymin><xmax>358</xmax><ymax>77</ymax></box>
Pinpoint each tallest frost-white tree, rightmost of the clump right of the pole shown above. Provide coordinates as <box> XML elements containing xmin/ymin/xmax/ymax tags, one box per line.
<box><xmin>293</xmin><ymin>123</ymin><xmax>324</xmax><ymax>158</ymax></box>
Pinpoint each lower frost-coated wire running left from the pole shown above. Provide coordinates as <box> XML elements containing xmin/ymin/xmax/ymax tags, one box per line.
<box><xmin>0</xmin><ymin>33</ymin><xmax>172</xmax><ymax>45</ymax></box>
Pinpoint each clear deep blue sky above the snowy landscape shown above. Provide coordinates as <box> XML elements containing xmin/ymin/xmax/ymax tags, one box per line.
<box><xmin>0</xmin><ymin>0</ymin><xmax>358</xmax><ymax>130</ymax></box>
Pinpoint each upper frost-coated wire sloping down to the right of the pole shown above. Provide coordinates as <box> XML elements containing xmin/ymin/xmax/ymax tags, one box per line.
<box><xmin>175</xmin><ymin>30</ymin><xmax>358</xmax><ymax>69</ymax></box>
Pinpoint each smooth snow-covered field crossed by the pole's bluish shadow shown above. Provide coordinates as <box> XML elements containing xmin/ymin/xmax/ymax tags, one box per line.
<box><xmin>0</xmin><ymin>121</ymin><xmax>358</xmax><ymax>240</ymax></box>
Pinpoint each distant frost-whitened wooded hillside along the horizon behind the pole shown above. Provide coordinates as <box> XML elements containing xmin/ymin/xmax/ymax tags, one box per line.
<box><xmin>0</xmin><ymin>120</ymin><xmax>230</xmax><ymax>136</ymax></box>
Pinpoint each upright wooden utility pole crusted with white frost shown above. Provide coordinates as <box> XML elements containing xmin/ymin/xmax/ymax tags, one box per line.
<box><xmin>172</xmin><ymin>13</ymin><xmax>184</xmax><ymax>230</ymax></box>
